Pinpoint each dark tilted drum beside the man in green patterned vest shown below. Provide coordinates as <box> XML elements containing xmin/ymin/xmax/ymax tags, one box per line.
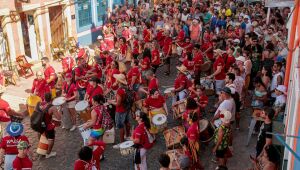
<box><xmin>199</xmin><ymin>119</ymin><xmax>215</xmax><ymax>143</ymax></box>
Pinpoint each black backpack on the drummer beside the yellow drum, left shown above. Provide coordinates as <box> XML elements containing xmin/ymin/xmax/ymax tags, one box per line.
<box><xmin>30</xmin><ymin>102</ymin><xmax>52</xmax><ymax>133</ymax></box>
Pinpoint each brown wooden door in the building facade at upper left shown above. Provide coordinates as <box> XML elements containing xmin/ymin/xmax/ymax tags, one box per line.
<box><xmin>49</xmin><ymin>6</ymin><xmax>65</xmax><ymax>45</ymax></box>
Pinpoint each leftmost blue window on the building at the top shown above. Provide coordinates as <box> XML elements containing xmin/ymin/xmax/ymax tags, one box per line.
<box><xmin>77</xmin><ymin>0</ymin><xmax>92</xmax><ymax>27</ymax></box>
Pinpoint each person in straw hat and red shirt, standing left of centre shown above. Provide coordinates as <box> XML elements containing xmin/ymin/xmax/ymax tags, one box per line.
<box><xmin>108</xmin><ymin>74</ymin><xmax>130</xmax><ymax>149</ymax></box>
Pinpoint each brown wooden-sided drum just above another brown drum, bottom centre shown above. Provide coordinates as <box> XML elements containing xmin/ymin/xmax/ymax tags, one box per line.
<box><xmin>164</xmin><ymin>126</ymin><xmax>185</xmax><ymax>149</ymax></box>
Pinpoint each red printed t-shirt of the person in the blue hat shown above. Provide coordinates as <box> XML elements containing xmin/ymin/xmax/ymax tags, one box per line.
<box><xmin>0</xmin><ymin>135</ymin><xmax>29</xmax><ymax>155</ymax></box>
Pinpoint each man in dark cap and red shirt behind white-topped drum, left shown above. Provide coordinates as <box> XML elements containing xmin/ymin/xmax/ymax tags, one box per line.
<box><xmin>84</xmin><ymin>77</ymin><xmax>103</xmax><ymax>106</ymax></box>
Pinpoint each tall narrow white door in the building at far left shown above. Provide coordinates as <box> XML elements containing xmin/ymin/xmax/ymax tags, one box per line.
<box><xmin>27</xmin><ymin>15</ymin><xmax>39</xmax><ymax>60</ymax></box>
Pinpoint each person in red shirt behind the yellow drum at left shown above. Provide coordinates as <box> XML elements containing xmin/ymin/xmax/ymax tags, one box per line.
<box><xmin>31</xmin><ymin>71</ymin><xmax>50</xmax><ymax>100</ymax></box>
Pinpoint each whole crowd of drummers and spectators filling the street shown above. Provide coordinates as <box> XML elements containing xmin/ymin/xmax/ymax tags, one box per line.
<box><xmin>0</xmin><ymin>0</ymin><xmax>291</xmax><ymax>170</ymax></box>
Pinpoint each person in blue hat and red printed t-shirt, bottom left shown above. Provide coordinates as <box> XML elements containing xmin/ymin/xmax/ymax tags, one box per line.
<box><xmin>0</xmin><ymin>122</ymin><xmax>29</xmax><ymax>170</ymax></box>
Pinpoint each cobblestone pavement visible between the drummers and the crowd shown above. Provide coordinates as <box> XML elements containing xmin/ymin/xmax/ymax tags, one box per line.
<box><xmin>3</xmin><ymin>58</ymin><xmax>255</xmax><ymax>170</ymax></box>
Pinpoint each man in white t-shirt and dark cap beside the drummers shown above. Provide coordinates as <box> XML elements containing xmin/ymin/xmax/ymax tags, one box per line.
<box><xmin>212</xmin><ymin>87</ymin><xmax>236</xmax><ymax>127</ymax></box>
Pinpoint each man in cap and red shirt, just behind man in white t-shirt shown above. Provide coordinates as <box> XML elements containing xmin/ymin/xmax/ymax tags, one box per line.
<box><xmin>208</xmin><ymin>49</ymin><xmax>226</xmax><ymax>94</ymax></box>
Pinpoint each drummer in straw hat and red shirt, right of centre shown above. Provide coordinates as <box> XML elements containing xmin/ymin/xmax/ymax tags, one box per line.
<box><xmin>173</xmin><ymin>65</ymin><xmax>188</xmax><ymax>103</ymax></box>
